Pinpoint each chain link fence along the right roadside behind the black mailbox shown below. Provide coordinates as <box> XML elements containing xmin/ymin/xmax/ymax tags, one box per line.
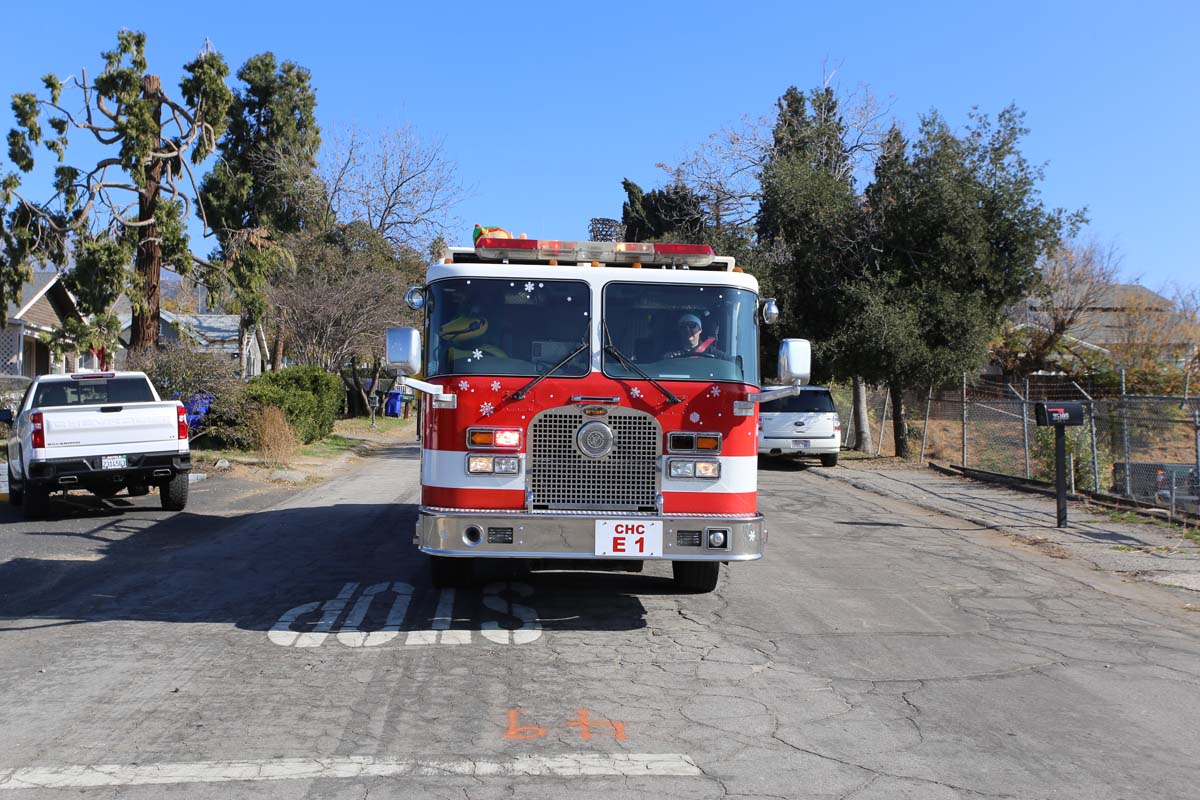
<box><xmin>834</xmin><ymin>375</ymin><xmax>1200</xmax><ymax>512</ymax></box>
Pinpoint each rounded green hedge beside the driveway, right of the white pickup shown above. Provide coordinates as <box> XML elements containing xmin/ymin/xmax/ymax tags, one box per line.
<box><xmin>246</xmin><ymin>367</ymin><xmax>344</xmax><ymax>444</ymax></box>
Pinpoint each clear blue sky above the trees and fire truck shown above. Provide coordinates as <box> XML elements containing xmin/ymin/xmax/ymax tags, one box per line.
<box><xmin>0</xmin><ymin>0</ymin><xmax>1200</xmax><ymax>288</ymax></box>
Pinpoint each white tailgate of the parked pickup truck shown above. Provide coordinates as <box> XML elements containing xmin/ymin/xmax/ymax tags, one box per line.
<box><xmin>41</xmin><ymin>402</ymin><xmax>179</xmax><ymax>458</ymax></box>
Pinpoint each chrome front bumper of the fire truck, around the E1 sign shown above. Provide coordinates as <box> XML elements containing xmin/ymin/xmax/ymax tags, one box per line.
<box><xmin>414</xmin><ymin>506</ymin><xmax>767</xmax><ymax>561</ymax></box>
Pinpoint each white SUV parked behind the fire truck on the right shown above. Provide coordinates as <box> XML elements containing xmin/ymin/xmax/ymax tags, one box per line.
<box><xmin>758</xmin><ymin>386</ymin><xmax>841</xmax><ymax>467</ymax></box>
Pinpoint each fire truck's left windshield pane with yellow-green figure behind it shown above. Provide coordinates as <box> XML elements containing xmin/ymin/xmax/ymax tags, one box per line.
<box><xmin>425</xmin><ymin>278</ymin><xmax>592</xmax><ymax>378</ymax></box>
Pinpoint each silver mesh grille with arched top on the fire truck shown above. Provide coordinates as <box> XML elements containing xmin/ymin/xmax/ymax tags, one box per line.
<box><xmin>527</xmin><ymin>407</ymin><xmax>662</xmax><ymax>511</ymax></box>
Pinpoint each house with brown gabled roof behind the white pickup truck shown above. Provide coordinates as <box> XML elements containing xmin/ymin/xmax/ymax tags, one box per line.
<box><xmin>0</xmin><ymin>272</ymin><xmax>83</xmax><ymax>378</ymax></box>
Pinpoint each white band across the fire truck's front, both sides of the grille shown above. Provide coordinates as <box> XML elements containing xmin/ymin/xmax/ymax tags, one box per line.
<box><xmin>421</xmin><ymin>450</ymin><xmax>758</xmax><ymax>494</ymax></box>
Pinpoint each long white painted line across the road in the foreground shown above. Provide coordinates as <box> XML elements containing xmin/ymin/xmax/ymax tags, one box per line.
<box><xmin>0</xmin><ymin>753</ymin><xmax>701</xmax><ymax>790</ymax></box>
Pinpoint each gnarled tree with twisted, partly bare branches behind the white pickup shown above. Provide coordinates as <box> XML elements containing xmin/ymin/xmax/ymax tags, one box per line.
<box><xmin>0</xmin><ymin>31</ymin><xmax>230</xmax><ymax>348</ymax></box>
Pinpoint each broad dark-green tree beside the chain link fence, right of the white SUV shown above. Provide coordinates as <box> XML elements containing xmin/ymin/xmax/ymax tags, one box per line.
<box><xmin>839</xmin><ymin>108</ymin><xmax>1082</xmax><ymax>456</ymax></box>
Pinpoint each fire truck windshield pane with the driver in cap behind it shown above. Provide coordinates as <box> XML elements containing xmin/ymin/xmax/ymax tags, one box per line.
<box><xmin>602</xmin><ymin>283</ymin><xmax>758</xmax><ymax>384</ymax></box>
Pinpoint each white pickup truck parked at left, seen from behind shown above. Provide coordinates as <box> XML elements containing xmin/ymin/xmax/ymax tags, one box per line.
<box><xmin>0</xmin><ymin>372</ymin><xmax>192</xmax><ymax>518</ymax></box>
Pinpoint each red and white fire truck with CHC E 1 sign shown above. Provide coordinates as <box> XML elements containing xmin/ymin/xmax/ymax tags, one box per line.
<box><xmin>388</xmin><ymin>236</ymin><xmax>810</xmax><ymax>591</ymax></box>
